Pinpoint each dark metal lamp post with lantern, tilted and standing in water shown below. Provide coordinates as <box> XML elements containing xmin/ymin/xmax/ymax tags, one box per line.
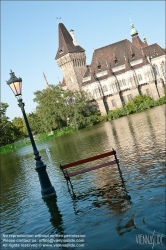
<box><xmin>6</xmin><ymin>70</ymin><xmax>56</xmax><ymax>198</ymax></box>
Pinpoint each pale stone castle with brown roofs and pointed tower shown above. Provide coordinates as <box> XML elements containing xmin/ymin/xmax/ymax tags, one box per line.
<box><xmin>55</xmin><ymin>21</ymin><xmax>166</xmax><ymax>114</ymax></box>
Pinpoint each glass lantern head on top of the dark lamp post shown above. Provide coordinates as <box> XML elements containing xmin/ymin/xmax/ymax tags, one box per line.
<box><xmin>6</xmin><ymin>70</ymin><xmax>22</xmax><ymax>97</ymax></box>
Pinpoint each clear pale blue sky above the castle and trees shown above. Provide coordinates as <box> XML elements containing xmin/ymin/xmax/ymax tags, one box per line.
<box><xmin>1</xmin><ymin>0</ymin><xmax>166</xmax><ymax>120</ymax></box>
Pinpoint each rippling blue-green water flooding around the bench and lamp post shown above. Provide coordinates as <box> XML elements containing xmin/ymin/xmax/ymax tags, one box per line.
<box><xmin>1</xmin><ymin>106</ymin><xmax>166</xmax><ymax>250</ymax></box>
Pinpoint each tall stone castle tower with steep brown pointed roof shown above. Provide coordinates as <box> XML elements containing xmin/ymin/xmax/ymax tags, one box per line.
<box><xmin>55</xmin><ymin>23</ymin><xmax>86</xmax><ymax>90</ymax></box>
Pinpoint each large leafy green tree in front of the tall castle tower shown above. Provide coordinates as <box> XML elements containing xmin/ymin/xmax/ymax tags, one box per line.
<box><xmin>34</xmin><ymin>85</ymin><xmax>99</xmax><ymax>132</ymax></box>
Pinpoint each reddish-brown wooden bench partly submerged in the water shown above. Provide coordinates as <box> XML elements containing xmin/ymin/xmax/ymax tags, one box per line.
<box><xmin>60</xmin><ymin>149</ymin><xmax>121</xmax><ymax>184</ymax></box>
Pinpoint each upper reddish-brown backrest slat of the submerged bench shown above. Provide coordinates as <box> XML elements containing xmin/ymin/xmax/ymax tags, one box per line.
<box><xmin>61</xmin><ymin>151</ymin><xmax>116</xmax><ymax>169</ymax></box>
